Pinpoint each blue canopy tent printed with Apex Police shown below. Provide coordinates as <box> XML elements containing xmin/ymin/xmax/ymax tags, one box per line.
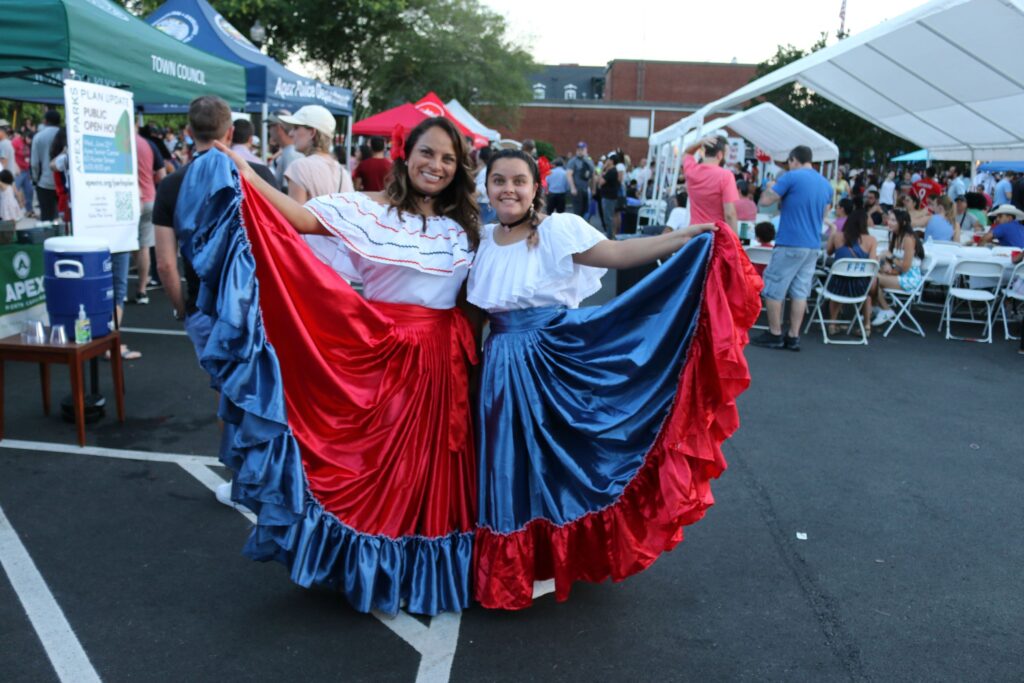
<box><xmin>145</xmin><ymin>0</ymin><xmax>352</xmax><ymax>156</ymax></box>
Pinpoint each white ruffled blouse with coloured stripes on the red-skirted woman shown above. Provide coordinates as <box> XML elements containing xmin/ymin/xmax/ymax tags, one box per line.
<box><xmin>305</xmin><ymin>193</ymin><xmax>473</xmax><ymax>308</ymax></box>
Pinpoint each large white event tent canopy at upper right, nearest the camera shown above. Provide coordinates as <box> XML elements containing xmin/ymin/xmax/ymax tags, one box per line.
<box><xmin>650</xmin><ymin>0</ymin><xmax>1024</xmax><ymax>210</ymax></box>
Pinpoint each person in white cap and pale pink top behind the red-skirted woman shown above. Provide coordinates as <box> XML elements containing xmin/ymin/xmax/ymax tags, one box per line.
<box><xmin>281</xmin><ymin>104</ymin><xmax>355</xmax><ymax>203</ymax></box>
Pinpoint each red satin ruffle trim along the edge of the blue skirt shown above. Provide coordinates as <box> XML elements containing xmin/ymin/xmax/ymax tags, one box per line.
<box><xmin>474</xmin><ymin>223</ymin><xmax>762</xmax><ymax>609</ymax></box>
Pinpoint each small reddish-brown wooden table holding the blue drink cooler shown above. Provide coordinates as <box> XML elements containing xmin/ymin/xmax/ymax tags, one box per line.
<box><xmin>0</xmin><ymin>332</ymin><xmax>125</xmax><ymax>446</ymax></box>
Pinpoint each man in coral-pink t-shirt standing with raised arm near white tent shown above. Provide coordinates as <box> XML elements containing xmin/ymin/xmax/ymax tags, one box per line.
<box><xmin>683</xmin><ymin>134</ymin><xmax>739</xmax><ymax>230</ymax></box>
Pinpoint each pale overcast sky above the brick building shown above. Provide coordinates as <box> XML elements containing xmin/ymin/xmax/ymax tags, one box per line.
<box><xmin>482</xmin><ymin>0</ymin><xmax>924</xmax><ymax>67</ymax></box>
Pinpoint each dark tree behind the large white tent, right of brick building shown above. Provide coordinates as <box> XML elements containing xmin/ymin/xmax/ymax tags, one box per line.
<box><xmin>749</xmin><ymin>33</ymin><xmax>915</xmax><ymax>166</ymax></box>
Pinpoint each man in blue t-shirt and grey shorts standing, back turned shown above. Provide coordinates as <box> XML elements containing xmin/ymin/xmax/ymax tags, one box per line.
<box><xmin>752</xmin><ymin>145</ymin><xmax>833</xmax><ymax>351</ymax></box>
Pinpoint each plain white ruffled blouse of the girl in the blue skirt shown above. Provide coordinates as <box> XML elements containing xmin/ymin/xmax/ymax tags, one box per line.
<box><xmin>468</xmin><ymin>213</ymin><xmax>607</xmax><ymax>311</ymax></box>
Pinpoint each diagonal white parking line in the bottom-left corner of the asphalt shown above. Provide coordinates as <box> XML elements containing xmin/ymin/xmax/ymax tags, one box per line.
<box><xmin>0</xmin><ymin>501</ymin><xmax>99</xmax><ymax>683</ymax></box>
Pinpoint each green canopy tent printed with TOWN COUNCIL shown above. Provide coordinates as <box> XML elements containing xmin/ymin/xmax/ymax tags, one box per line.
<box><xmin>0</xmin><ymin>0</ymin><xmax>246</xmax><ymax>109</ymax></box>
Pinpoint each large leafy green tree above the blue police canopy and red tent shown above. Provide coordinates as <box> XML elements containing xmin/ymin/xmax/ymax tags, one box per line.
<box><xmin>121</xmin><ymin>0</ymin><xmax>536</xmax><ymax>118</ymax></box>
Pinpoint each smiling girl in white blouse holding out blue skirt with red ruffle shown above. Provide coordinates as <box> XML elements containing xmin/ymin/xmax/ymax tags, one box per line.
<box><xmin>468</xmin><ymin>151</ymin><xmax>761</xmax><ymax>609</ymax></box>
